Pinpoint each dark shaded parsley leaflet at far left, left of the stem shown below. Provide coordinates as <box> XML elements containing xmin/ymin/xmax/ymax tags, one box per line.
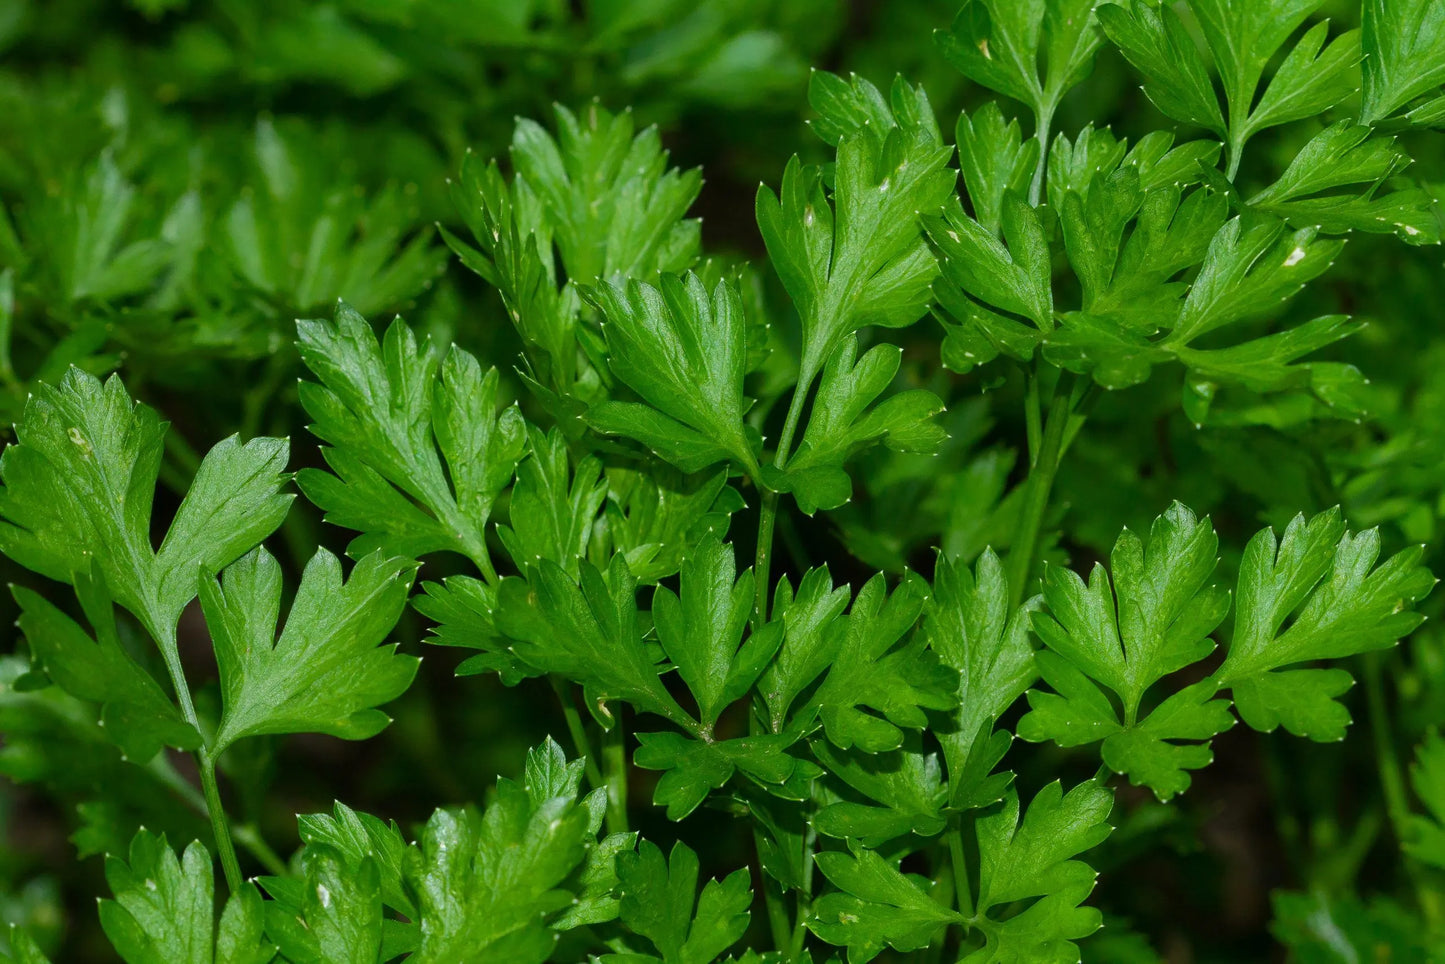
<box><xmin>10</xmin><ymin>574</ymin><xmax>201</xmax><ymax>763</ymax></box>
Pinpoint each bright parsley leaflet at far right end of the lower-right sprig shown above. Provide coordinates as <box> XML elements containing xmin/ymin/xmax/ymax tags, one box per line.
<box><xmin>1215</xmin><ymin>509</ymin><xmax>1435</xmax><ymax>741</ymax></box>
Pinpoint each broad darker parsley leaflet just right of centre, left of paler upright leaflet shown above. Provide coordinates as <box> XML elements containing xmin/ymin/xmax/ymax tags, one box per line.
<box><xmin>812</xmin><ymin>572</ymin><xmax>957</xmax><ymax>753</ymax></box>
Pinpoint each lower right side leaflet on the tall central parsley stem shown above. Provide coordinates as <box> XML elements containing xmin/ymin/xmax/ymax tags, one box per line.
<box><xmin>780</xmin><ymin>335</ymin><xmax>946</xmax><ymax>515</ymax></box>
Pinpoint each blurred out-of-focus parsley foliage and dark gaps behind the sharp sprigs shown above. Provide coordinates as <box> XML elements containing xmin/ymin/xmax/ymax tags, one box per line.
<box><xmin>0</xmin><ymin>0</ymin><xmax>1445</xmax><ymax>963</ymax></box>
